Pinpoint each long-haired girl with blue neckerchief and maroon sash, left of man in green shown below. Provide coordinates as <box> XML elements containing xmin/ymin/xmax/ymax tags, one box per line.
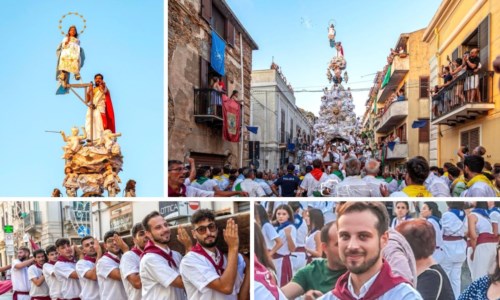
<box><xmin>273</xmin><ymin>204</ymin><xmax>297</xmax><ymax>286</ymax></box>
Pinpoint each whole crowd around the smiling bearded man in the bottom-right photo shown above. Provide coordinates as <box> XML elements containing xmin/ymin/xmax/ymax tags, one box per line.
<box><xmin>254</xmin><ymin>201</ymin><xmax>500</xmax><ymax>300</ymax></box>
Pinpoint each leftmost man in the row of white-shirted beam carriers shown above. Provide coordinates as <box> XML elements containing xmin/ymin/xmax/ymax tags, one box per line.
<box><xmin>11</xmin><ymin>247</ymin><xmax>35</xmax><ymax>300</ymax></box>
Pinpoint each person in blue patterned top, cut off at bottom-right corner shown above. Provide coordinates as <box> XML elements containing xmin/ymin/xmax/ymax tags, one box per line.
<box><xmin>458</xmin><ymin>244</ymin><xmax>500</xmax><ymax>300</ymax></box>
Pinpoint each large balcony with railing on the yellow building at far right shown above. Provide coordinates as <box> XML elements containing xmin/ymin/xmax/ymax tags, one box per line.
<box><xmin>431</xmin><ymin>71</ymin><xmax>495</xmax><ymax>126</ymax></box>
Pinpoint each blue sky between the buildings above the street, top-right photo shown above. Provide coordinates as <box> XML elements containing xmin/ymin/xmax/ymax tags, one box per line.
<box><xmin>227</xmin><ymin>0</ymin><xmax>441</xmax><ymax>115</ymax></box>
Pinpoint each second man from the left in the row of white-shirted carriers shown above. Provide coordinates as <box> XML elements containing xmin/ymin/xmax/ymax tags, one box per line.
<box><xmin>28</xmin><ymin>249</ymin><xmax>50</xmax><ymax>300</ymax></box>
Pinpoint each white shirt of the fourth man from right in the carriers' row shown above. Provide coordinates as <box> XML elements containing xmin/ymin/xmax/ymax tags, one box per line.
<box><xmin>96</xmin><ymin>252</ymin><xmax>127</xmax><ymax>300</ymax></box>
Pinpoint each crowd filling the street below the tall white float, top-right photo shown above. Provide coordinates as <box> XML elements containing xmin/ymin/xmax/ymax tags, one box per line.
<box><xmin>168</xmin><ymin>144</ymin><xmax>500</xmax><ymax>197</ymax></box>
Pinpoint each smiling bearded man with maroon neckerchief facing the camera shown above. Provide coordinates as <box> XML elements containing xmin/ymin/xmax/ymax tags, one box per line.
<box><xmin>321</xmin><ymin>202</ymin><xmax>422</xmax><ymax>300</ymax></box>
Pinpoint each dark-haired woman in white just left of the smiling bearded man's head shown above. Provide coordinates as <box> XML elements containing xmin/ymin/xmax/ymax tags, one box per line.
<box><xmin>306</xmin><ymin>208</ymin><xmax>325</xmax><ymax>264</ymax></box>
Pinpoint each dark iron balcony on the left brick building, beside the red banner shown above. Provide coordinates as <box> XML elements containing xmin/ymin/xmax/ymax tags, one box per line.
<box><xmin>194</xmin><ymin>89</ymin><xmax>222</xmax><ymax>127</ymax></box>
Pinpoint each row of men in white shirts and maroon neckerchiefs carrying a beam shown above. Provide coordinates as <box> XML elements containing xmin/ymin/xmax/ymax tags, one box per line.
<box><xmin>6</xmin><ymin>209</ymin><xmax>250</xmax><ymax>300</ymax></box>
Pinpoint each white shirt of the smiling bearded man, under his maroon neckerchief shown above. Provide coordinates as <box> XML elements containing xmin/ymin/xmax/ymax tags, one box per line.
<box><xmin>319</xmin><ymin>273</ymin><xmax>423</xmax><ymax>300</ymax></box>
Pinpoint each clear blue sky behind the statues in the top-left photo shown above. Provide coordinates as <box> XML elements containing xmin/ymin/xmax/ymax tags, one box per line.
<box><xmin>0</xmin><ymin>0</ymin><xmax>164</xmax><ymax>197</ymax></box>
